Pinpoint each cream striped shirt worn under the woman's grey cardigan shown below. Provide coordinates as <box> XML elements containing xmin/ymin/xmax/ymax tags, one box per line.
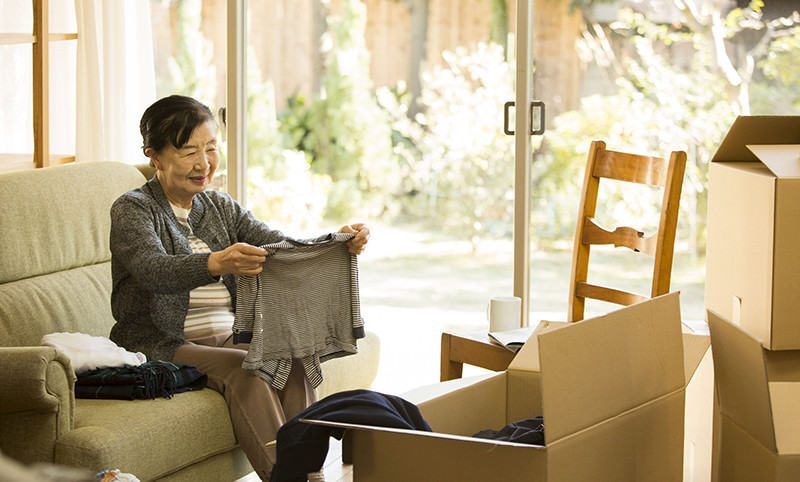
<box><xmin>171</xmin><ymin>204</ymin><xmax>234</xmax><ymax>339</ymax></box>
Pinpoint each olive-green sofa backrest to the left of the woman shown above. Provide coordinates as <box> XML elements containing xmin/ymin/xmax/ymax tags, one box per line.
<box><xmin>0</xmin><ymin>162</ymin><xmax>145</xmax><ymax>346</ymax></box>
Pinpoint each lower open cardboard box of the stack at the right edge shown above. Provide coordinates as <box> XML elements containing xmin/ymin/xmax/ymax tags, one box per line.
<box><xmin>708</xmin><ymin>310</ymin><xmax>800</xmax><ymax>482</ymax></box>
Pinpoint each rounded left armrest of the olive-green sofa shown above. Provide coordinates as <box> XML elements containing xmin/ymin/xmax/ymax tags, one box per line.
<box><xmin>0</xmin><ymin>346</ymin><xmax>75</xmax><ymax>464</ymax></box>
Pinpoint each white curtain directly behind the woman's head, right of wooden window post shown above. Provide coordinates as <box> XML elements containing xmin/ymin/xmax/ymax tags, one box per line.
<box><xmin>75</xmin><ymin>0</ymin><xmax>156</xmax><ymax>164</ymax></box>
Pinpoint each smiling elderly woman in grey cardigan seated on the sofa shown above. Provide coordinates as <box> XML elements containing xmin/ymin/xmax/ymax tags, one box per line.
<box><xmin>111</xmin><ymin>95</ymin><xmax>369</xmax><ymax>480</ymax></box>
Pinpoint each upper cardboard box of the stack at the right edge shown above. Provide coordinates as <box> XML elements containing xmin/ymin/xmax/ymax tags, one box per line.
<box><xmin>706</xmin><ymin>116</ymin><xmax>800</xmax><ymax>350</ymax></box>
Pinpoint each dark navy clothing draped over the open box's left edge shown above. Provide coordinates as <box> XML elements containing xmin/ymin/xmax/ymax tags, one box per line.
<box><xmin>270</xmin><ymin>390</ymin><xmax>431</xmax><ymax>482</ymax></box>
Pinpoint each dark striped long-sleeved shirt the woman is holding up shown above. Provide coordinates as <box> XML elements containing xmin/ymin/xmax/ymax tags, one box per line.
<box><xmin>233</xmin><ymin>233</ymin><xmax>365</xmax><ymax>390</ymax></box>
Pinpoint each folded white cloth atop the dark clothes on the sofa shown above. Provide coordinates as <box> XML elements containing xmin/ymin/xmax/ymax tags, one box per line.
<box><xmin>41</xmin><ymin>333</ymin><xmax>147</xmax><ymax>375</ymax></box>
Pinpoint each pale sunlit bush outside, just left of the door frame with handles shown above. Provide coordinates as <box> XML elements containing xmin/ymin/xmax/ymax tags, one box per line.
<box><xmin>395</xmin><ymin>44</ymin><xmax>514</xmax><ymax>242</ymax></box>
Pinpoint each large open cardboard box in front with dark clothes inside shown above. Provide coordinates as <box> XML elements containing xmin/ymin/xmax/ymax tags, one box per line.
<box><xmin>310</xmin><ymin>293</ymin><xmax>708</xmax><ymax>482</ymax></box>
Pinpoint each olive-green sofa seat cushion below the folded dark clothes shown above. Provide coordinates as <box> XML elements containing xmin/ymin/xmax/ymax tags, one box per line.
<box><xmin>55</xmin><ymin>388</ymin><xmax>237</xmax><ymax>480</ymax></box>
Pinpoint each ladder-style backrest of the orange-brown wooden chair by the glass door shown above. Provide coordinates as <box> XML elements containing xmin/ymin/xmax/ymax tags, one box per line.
<box><xmin>567</xmin><ymin>141</ymin><xmax>686</xmax><ymax>321</ymax></box>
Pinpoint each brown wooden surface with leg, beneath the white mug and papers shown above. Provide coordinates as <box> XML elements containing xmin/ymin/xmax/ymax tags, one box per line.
<box><xmin>440</xmin><ymin>330</ymin><xmax>515</xmax><ymax>381</ymax></box>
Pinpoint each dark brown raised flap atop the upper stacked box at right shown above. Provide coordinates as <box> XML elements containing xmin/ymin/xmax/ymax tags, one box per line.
<box><xmin>711</xmin><ymin>115</ymin><xmax>800</xmax><ymax>162</ymax></box>
